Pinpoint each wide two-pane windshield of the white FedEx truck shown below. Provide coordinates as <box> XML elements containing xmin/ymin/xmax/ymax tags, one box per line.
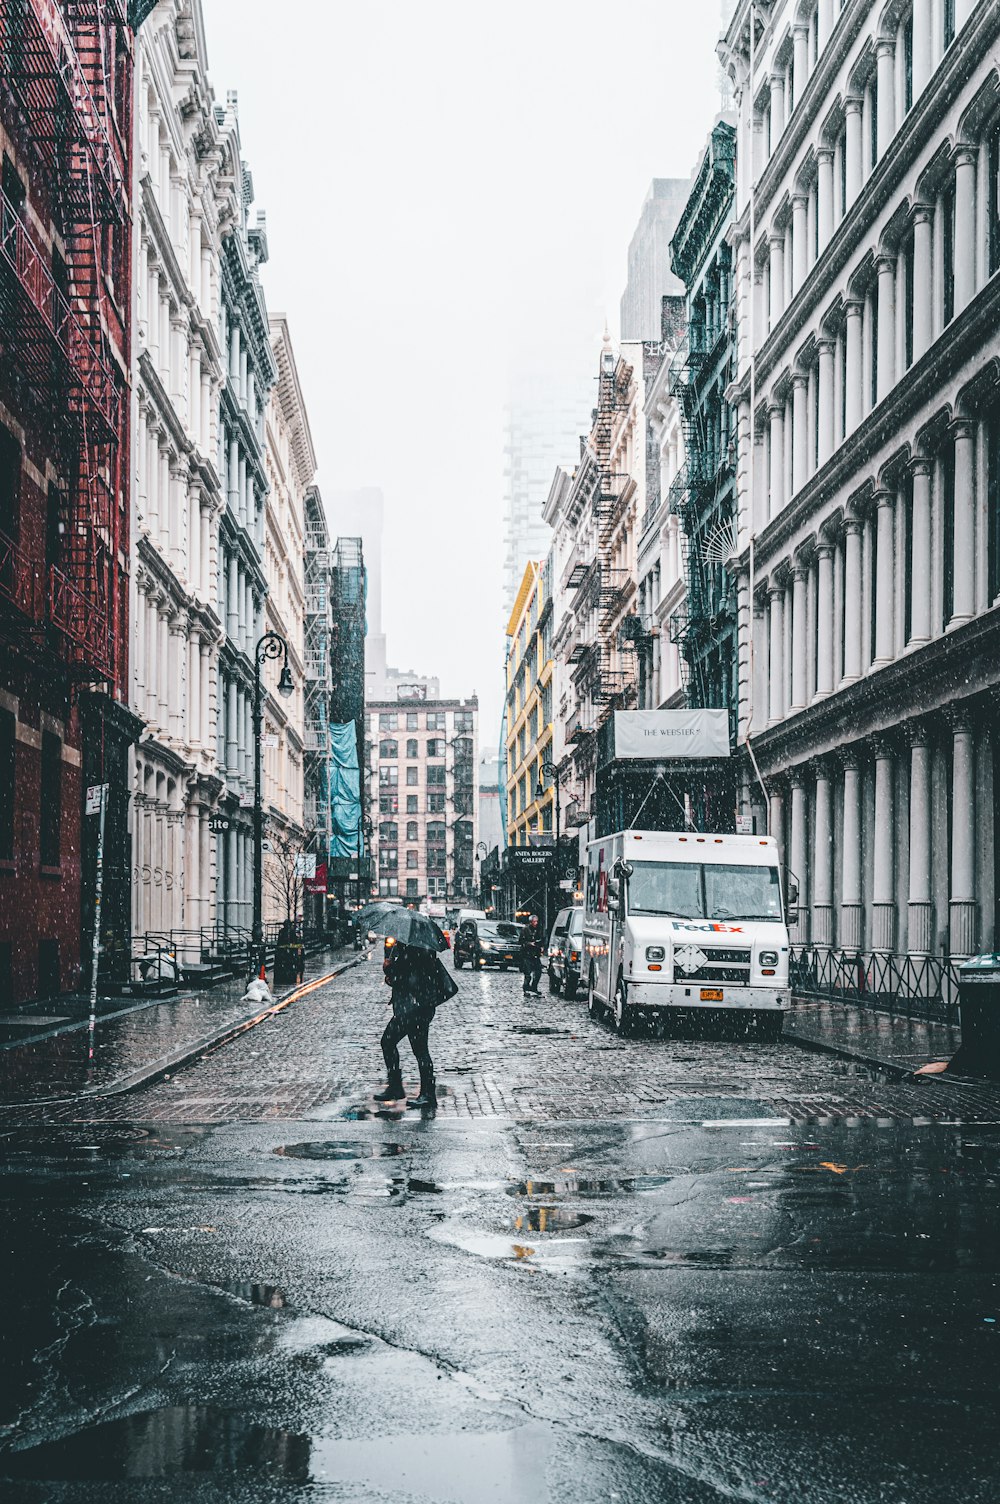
<box><xmin>627</xmin><ymin>862</ymin><xmax>782</xmax><ymax>922</ymax></box>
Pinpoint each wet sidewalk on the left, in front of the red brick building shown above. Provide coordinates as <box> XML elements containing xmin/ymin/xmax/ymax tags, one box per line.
<box><xmin>0</xmin><ymin>948</ymin><xmax>356</xmax><ymax>1107</ymax></box>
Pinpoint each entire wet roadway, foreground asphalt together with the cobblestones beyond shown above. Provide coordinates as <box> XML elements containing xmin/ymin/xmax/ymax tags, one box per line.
<box><xmin>0</xmin><ymin>966</ymin><xmax>1000</xmax><ymax>1504</ymax></box>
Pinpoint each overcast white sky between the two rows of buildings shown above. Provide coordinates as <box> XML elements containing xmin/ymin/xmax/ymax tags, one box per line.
<box><xmin>203</xmin><ymin>0</ymin><xmax>722</xmax><ymax>727</ymax></box>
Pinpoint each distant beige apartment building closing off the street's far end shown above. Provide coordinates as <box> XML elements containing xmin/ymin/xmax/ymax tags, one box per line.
<box><xmin>365</xmin><ymin>696</ymin><xmax>478</xmax><ymax>902</ymax></box>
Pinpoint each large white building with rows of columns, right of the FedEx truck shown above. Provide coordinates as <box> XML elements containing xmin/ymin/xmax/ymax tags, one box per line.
<box><xmin>725</xmin><ymin>0</ymin><xmax>1000</xmax><ymax>991</ymax></box>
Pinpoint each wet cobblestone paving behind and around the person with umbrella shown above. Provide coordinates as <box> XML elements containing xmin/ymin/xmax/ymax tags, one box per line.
<box><xmin>6</xmin><ymin>954</ymin><xmax>1000</xmax><ymax>1123</ymax></box>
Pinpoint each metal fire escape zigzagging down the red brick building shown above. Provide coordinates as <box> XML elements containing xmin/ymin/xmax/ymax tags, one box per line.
<box><xmin>0</xmin><ymin>0</ymin><xmax>131</xmax><ymax>692</ymax></box>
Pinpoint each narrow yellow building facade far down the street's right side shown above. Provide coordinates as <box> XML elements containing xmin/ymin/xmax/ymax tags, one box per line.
<box><xmin>507</xmin><ymin>561</ymin><xmax>555</xmax><ymax>847</ymax></box>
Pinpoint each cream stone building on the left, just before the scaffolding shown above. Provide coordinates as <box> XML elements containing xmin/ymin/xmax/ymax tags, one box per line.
<box><xmin>262</xmin><ymin>313</ymin><xmax>306</xmax><ymax>923</ymax></box>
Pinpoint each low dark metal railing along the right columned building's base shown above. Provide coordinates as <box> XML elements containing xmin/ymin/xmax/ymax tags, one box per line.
<box><xmin>788</xmin><ymin>946</ymin><xmax>959</xmax><ymax>1024</ymax></box>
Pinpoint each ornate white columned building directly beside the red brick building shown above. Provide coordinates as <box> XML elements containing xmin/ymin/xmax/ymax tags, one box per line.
<box><xmin>131</xmin><ymin>0</ymin><xmax>227</xmax><ymax>957</ymax></box>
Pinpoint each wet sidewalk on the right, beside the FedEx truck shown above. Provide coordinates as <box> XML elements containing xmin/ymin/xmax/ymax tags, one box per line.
<box><xmin>785</xmin><ymin>997</ymin><xmax>961</xmax><ymax>1075</ymax></box>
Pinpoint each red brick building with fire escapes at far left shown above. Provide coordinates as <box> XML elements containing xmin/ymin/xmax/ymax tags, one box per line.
<box><xmin>0</xmin><ymin>0</ymin><xmax>138</xmax><ymax>1003</ymax></box>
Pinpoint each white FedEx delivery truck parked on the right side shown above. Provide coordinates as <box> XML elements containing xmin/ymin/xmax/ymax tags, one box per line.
<box><xmin>583</xmin><ymin>830</ymin><xmax>791</xmax><ymax>1038</ymax></box>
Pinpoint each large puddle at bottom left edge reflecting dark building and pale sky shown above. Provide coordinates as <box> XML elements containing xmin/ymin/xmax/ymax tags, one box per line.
<box><xmin>0</xmin><ymin>1405</ymin><xmax>552</xmax><ymax>1504</ymax></box>
